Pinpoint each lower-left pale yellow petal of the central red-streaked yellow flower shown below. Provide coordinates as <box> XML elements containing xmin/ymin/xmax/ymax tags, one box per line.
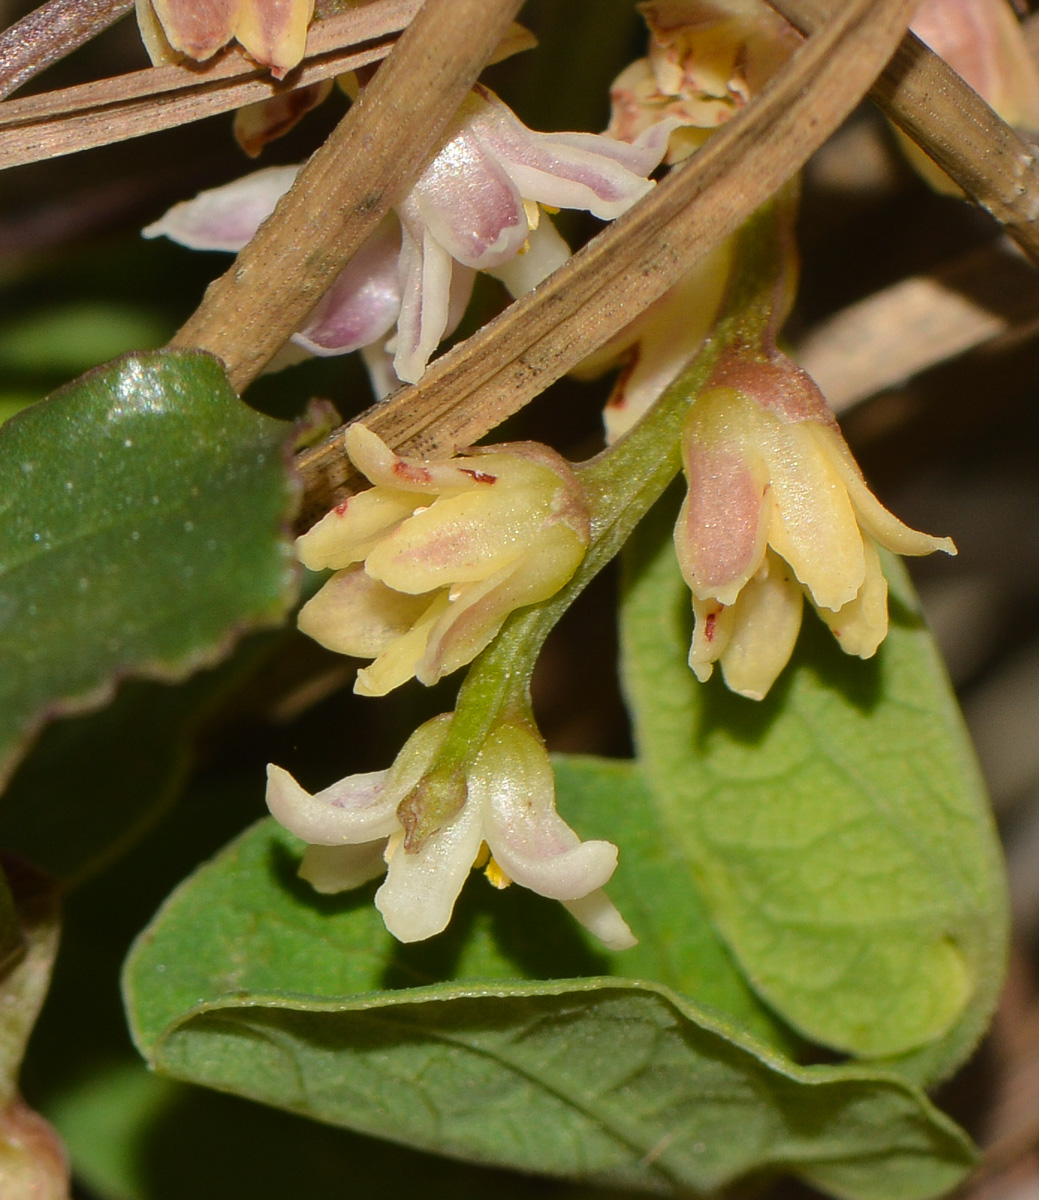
<box><xmin>298</xmin><ymin>566</ymin><xmax>430</xmax><ymax>662</ymax></box>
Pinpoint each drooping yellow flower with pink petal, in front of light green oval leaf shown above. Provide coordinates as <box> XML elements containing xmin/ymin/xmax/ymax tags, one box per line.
<box><xmin>674</xmin><ymin>356</ymin><xmax>956</xmax><ymax>700</ymax></box>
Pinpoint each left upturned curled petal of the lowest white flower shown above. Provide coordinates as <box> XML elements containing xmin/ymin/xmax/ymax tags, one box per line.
<box><xmin>266</xmin><ymin>763</ymin><xmax>402</xmax><ymax>846</ymax></box>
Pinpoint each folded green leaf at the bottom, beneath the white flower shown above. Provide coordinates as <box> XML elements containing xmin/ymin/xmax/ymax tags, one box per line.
<box><xmin>125</xmin><ymin>820</ymin><xmax>972</xmax><ymax>1200</ymax></box>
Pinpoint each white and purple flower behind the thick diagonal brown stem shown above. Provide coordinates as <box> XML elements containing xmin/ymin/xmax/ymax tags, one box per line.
<box><xmin>144</xmin><ymin>86</ymin><xmax>669</xmax><ymax>393</ymax></box>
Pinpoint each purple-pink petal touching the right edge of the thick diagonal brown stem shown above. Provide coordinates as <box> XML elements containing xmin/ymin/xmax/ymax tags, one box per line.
<box><xmin>293</xmin><ymin>216</ymin><xmax>401</xmax><ymax>356</ymax></box>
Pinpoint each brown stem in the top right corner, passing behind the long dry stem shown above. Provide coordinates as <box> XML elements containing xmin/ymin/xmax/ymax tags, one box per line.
<box><xmin>769</xmin><ymin>0</ymin><xmax>1039</xmax><ymax>263</ymax></box>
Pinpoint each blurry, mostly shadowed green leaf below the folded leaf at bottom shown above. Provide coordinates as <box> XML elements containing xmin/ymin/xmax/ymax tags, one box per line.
<box><xmin>48</xmin><ymin>1060</ymin><xmax>621</xmax><ymax>1200</ymax></box>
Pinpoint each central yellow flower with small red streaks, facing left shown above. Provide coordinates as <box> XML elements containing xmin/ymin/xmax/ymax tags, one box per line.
<box><xmin>296</xmin><ymin>425</ymin><xmax>589</xmax><ymax>696</ymax></box>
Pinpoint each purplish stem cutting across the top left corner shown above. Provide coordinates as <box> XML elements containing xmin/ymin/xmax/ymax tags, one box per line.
<box><xmin>0</xmin><ymin>0</ymin><xmax>133</xmax><ymax>98</ymax></box>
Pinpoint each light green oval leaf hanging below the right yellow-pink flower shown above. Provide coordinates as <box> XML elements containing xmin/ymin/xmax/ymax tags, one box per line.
<box><xmin>623</xmin><ymin>492</ymin><xmax>1007</xmax><ymax>1081</ymax></box>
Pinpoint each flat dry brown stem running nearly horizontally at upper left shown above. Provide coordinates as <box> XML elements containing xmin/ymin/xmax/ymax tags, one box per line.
<box><xmin>0</xmin><ymin>0</ymin><xmax>421</xmax><ymax>168</ymax></box>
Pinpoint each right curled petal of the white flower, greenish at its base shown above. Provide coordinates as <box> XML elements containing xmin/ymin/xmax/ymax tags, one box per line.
<box><xmin>468</xmin><ymin>725</ymin><xmax>617</xmax><ymax>900</ymax></box>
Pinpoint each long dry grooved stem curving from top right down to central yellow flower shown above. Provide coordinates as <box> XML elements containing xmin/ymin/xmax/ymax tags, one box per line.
<box><xmin>291</xmin><ymin>0</ymin><xmax>915</xmax><ymax>530</ymax></box>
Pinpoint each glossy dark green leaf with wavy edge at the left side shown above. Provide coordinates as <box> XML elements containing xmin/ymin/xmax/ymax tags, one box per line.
<box><xmin>0</xmin><ymin>353</ymin><xmax>296</xmax><ymax>778</ymax></box>
